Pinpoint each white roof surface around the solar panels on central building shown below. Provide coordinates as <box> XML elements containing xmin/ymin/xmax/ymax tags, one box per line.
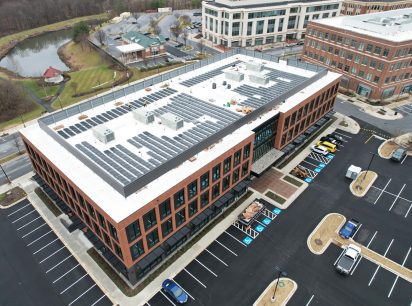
<box><xmin>21</xmin><ymin>54</ymin><xmax>340</xmax><ymax>222</ymax></box>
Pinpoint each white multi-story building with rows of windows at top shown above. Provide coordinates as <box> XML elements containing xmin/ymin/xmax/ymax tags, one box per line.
<box><xmin>202</xmin><ymin>0</ymin><xmax>342</xmax><ymax>47</ymax></box>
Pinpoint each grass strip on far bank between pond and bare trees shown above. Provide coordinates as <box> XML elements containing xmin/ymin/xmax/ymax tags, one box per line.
<box><xmin>0</xmin><ymin>13</ymin><xmax>108</xmax><ymax>52</ymax></box>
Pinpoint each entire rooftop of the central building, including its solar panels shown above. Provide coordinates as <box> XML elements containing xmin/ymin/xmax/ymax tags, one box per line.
<box><xmin>22</xmin><ymin>54</ymin><xmax>340</xmax><ymax>221</ymax></box>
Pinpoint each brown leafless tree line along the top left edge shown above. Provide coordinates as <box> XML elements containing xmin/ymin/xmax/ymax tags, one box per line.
<box><xmin>0</xmin><ymin>0</ymin><xmax>201</xmax><ymax>36</ymax></box>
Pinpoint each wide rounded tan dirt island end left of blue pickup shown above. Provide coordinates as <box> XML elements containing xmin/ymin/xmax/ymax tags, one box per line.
<box><xmin>308</xmin><ymin>213</ymin><xmax>346</xmax><ymax>255</ymax></box>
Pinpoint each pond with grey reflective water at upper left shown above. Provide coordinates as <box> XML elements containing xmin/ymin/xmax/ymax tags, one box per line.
<box><xmin>0</xmin><ymin>29</ymin><xmax>72</xmax><ymax>77</ymax></box>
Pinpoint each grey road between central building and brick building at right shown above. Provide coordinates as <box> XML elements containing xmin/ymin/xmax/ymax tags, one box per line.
<box><xmin>334</xmin><ymin>98</ymin><xmax>412</xmax><ymax>135</ymax></box>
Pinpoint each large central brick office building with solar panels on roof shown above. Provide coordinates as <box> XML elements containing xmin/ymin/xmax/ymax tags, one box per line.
<box><xmin>21</xmin><ymin>50</ymin><xmax>340</xmax><ymax>284</ymax></box>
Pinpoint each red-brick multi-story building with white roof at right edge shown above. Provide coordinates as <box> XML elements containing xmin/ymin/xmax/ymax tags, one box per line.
<box><xmin>302</xmin><ymin>8</ymin><xmax>412</xmax><ymax>101</ymax></box>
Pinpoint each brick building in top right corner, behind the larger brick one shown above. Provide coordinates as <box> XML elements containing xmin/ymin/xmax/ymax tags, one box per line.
<box><xmin>341</xmin><ymin>0</ymin><xmax>412</xmax><ymax>16</ymax></box>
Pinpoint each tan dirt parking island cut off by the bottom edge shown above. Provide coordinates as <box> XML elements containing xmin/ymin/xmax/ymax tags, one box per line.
<box><xmin>253</xmin><ymin>278</ymin><xmax>297</xmax><ymax>306</ymax></box>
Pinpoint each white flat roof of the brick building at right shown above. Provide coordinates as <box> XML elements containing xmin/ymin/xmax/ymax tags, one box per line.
<box><xmin>313</xmin><ymin>8</ymin><xmax>412</xmax><ymax>42</ymax></box>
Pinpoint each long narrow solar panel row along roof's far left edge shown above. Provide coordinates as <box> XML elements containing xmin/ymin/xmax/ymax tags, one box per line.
<box><xmin>57</xmin><ymin>88</ymin><xmax>177</xmax><ymax>139</ymax></box>
